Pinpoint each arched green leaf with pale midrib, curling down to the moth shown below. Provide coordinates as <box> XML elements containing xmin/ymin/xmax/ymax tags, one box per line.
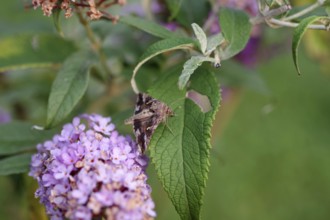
<box><xmin>132</xmin><ymin>38</ymin><xmax>195</xmax><ymax>89</ymax></box>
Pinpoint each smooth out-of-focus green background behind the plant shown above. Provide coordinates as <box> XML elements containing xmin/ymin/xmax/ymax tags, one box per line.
<box><xmin>0</xmin><ymin>1</ymin><xmax>330</xmax><ymax>220</ymax></box>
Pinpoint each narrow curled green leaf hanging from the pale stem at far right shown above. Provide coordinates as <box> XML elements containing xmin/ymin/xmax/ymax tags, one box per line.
<box><xmin>291</xmin><ymin>16</ymin><xmax>325</xmax><ymax>74</ymax></box>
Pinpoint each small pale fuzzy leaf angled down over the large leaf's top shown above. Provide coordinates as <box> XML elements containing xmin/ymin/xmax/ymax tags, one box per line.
<box><xmin>178</xmin><ymin>56</ymin><xmax>213</xmax><ymax>89</ymax></box>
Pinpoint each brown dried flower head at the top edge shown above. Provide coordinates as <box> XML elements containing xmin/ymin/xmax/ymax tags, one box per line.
<box><xmin>32</xmin><ymin>0</ymin><xmax>126</xmax><ymax>22</ymax></box>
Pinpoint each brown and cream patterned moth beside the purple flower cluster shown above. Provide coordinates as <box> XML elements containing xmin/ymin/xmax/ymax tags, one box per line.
<box><xmin>125</xmin><ymin>93</ymin><xmax>174</xmax><ymax>154</ymax></box>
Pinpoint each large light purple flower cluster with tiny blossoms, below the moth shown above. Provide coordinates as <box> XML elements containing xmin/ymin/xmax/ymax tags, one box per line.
<box><xmin>29</xmin><ymin>114</ymin><xmax>156</xmax><ymax>220</ymax></box>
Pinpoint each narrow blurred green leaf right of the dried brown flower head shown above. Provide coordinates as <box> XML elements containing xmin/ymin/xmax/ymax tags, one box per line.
<box><xmin>119</xmin><ymin>16</ymin><xmax>178</xmax><ymax>38</ymax></box>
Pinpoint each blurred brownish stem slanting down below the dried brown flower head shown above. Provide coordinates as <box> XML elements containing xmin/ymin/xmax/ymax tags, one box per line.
<box><xmin>77</xmin><ymin>10</ymin><xmax>112</xmax><ymax>78</ymax></box>
